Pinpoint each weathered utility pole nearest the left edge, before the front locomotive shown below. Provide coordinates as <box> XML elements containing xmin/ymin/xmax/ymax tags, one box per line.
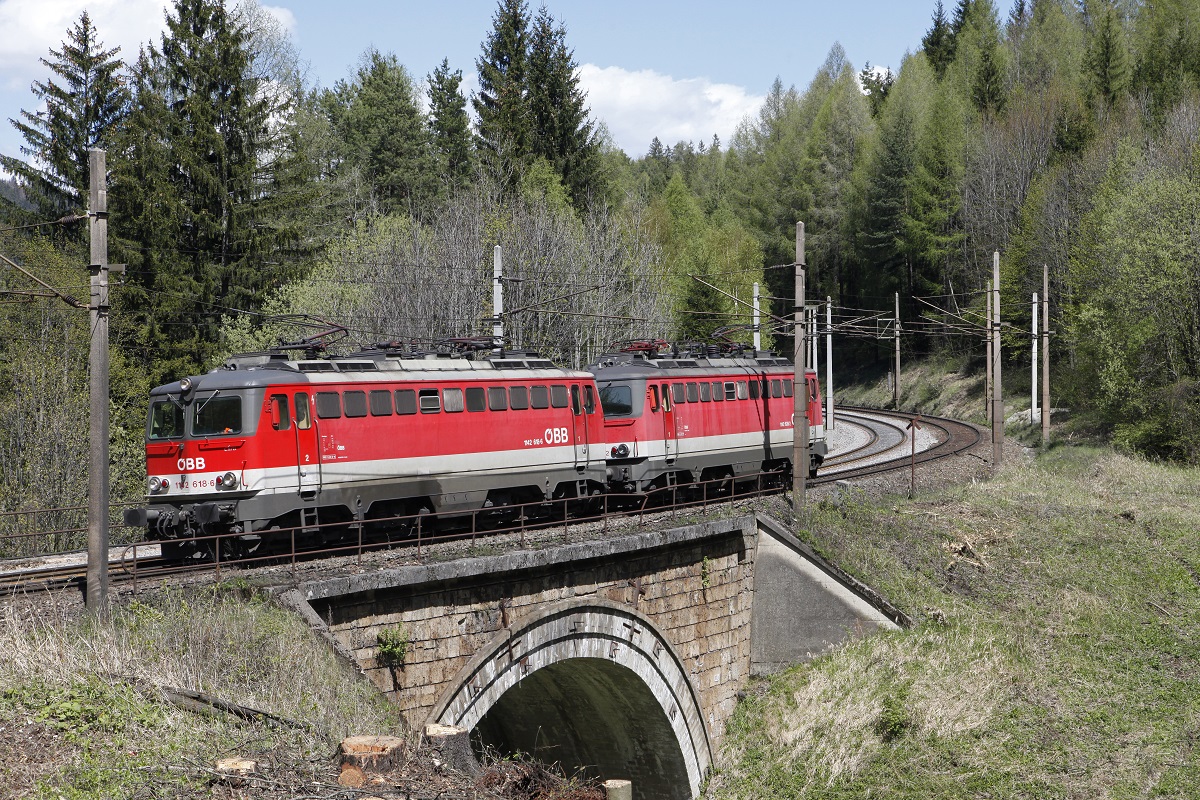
<box><xmin>86</xmin><ymin>148</ymin><xmax>108</xmax><ymax>614</ymax></box>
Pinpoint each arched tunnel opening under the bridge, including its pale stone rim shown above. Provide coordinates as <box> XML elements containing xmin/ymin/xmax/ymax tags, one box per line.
<box><xmin>430</xmin><ymin>599</ymin><xmax>712</xmax><ymax>800</ymax></box>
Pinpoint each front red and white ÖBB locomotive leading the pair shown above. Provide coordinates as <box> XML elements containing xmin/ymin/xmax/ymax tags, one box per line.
<box><xmin>125</xmin><ymin>349</ymin><xmax>605</xmax><ymax>558</ymax></box>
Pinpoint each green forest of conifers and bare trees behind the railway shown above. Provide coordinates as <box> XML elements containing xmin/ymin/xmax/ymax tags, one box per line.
<box><xmin>0</xmin><ymin>0</ymin><xmax>1200</xmax><ymax>520</ymax></box>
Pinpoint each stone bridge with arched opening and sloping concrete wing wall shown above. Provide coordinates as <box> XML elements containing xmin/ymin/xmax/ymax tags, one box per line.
<box><xmin>283</xmin><ymin>516</ymin><xmax>902</xmax><ymax>798</ymax></box>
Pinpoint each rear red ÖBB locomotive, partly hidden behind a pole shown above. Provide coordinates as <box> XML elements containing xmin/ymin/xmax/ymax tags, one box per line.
<box><xmin>589</xmin><ymin>341</ymin><xmax>828</xmax><ymax>493</ymax></box>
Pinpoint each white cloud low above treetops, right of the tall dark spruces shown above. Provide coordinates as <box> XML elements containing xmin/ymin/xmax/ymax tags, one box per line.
<box><xmin>580</xmin><ymin>64</ymin><xmax>764</xmax><ymax>158</ymax></box>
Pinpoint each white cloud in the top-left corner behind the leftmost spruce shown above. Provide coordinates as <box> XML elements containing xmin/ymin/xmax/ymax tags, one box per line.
<box><xmin>0</xmin><ymin>0</ymin><xmax>167</xmax><ymax>90</ymax></box>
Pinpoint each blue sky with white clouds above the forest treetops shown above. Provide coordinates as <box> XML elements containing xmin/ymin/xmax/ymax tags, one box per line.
<box><xmin>0</xmin><ymin>0</ymin><xmax>949</xmax><ymax>170</ymax></box>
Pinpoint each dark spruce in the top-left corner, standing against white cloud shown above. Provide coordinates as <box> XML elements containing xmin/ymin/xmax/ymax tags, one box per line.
<box><xmin>0</xmin><ymin>11</ymin><xmax>128</xmax><ymax>217</ymax></box>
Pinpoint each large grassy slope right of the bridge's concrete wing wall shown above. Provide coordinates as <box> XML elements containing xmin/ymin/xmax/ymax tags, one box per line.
<box><xmin>707</xmin><ymin>446</ymin><xmax>1200</xmax><ymax>799</ymax></box>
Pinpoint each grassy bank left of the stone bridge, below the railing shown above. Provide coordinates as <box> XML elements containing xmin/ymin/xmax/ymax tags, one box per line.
<box><xmin>0</xmin><ymin>589</ymin><xmax>401</xmax><ymax>800</ymax></box>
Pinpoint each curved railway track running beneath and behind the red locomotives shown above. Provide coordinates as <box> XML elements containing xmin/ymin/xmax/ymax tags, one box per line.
<box><xmin>0</xmin><ymin>407</ymin><xmax>982</xmax><ymax>596</ymax></box>
